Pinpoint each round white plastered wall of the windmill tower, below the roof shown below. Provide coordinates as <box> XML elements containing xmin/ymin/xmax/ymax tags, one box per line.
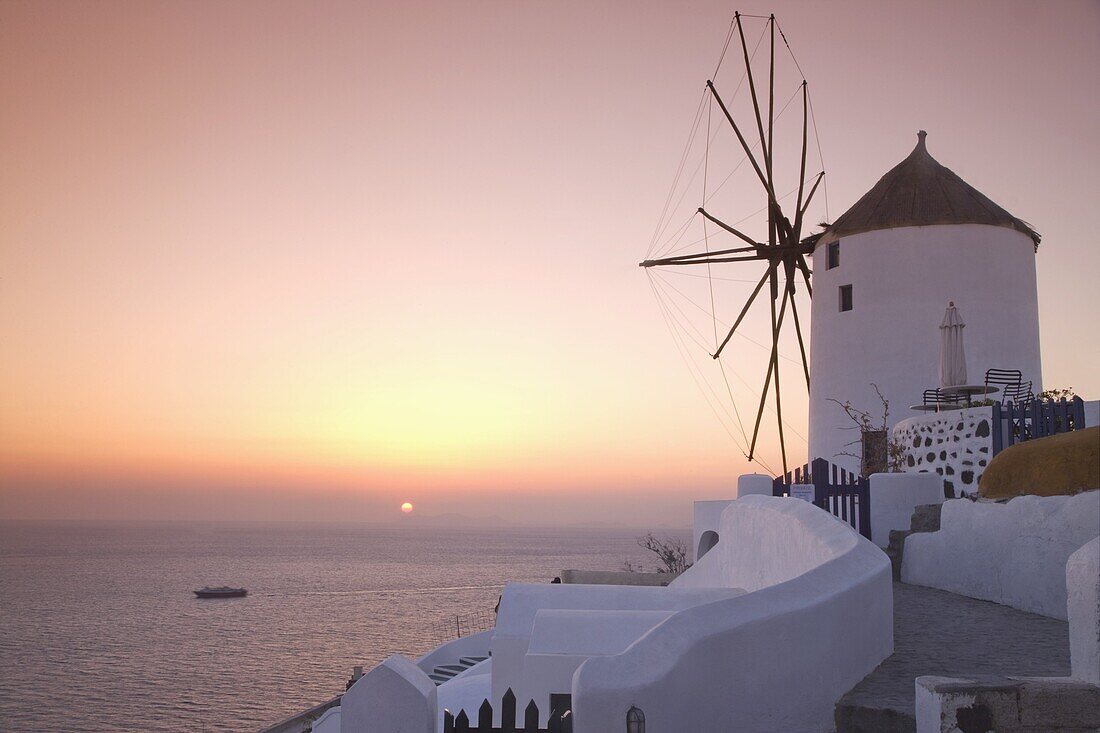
<box><xmin>810</xmin><ymin>225</ymin><xmax>1042</xmax><ymax>471</ymax></box>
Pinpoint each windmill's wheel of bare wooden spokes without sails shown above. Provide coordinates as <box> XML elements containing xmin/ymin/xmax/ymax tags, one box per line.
<box><xmin>639</xmin><ymin>12</ymin><xmax>825</xmax><ymax>473</ymax></box>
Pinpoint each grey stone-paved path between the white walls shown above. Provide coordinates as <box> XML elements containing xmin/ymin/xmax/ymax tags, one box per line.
<box><xmin>836</xmin><ymin>583</ymin><xmax>1069</xmax><ymax>733</ymax></box>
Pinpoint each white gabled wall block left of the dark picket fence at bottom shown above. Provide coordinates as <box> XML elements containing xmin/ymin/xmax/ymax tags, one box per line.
<box><xmin>340</xmin><ymin>654</ymin><xmax>437</xmax><ymax>733</ymax></box>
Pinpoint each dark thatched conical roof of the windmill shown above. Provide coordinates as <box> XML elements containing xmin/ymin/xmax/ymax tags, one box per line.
<box><xmin>826</xmin><ymin>130</ymin><xmax>1041</xmax><ymax>248</ymax></box>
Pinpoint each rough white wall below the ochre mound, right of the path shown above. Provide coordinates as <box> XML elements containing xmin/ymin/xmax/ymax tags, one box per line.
<box><xmin>901</xmin><ymin>491</ymin><xmax>1100</xmax><ymax>620</ymax></box>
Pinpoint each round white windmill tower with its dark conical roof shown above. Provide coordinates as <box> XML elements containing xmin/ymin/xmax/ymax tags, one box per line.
<box><xmin>809</xmin><ymin>130</ymin><xmax>1042</xmax><ymax>471</ymax></box>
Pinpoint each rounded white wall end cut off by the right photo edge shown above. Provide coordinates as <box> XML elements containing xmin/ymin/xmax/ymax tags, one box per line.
<box><xmin>1066</xmin><ymin>537</ymin><xmax>1100</xmax><ymax>685</ymax></box>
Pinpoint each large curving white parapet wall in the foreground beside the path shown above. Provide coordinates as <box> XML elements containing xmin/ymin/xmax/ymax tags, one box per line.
<box><xmin>573</xmin><ymin>496</ymin><xmax>893</xmax><ymax>733</ymax></box>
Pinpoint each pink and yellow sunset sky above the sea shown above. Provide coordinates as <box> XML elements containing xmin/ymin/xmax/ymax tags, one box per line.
<box><xmin>0</xmin><ymin>0</ymin><xmax>1100</xmax><ymax>525</ymax></box>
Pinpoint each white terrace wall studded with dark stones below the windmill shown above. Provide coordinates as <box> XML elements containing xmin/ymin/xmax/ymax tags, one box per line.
<box><xmin>893</xmin><ymin>407</ymin><xmax>993</xmax><ymax>499</ymax></box>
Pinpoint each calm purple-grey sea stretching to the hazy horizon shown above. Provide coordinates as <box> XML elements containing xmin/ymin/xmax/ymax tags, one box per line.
<box><xmin>0</xmin><ymin>523</ymin><xmax>689</xmax><ymax>733</ymax></box>
